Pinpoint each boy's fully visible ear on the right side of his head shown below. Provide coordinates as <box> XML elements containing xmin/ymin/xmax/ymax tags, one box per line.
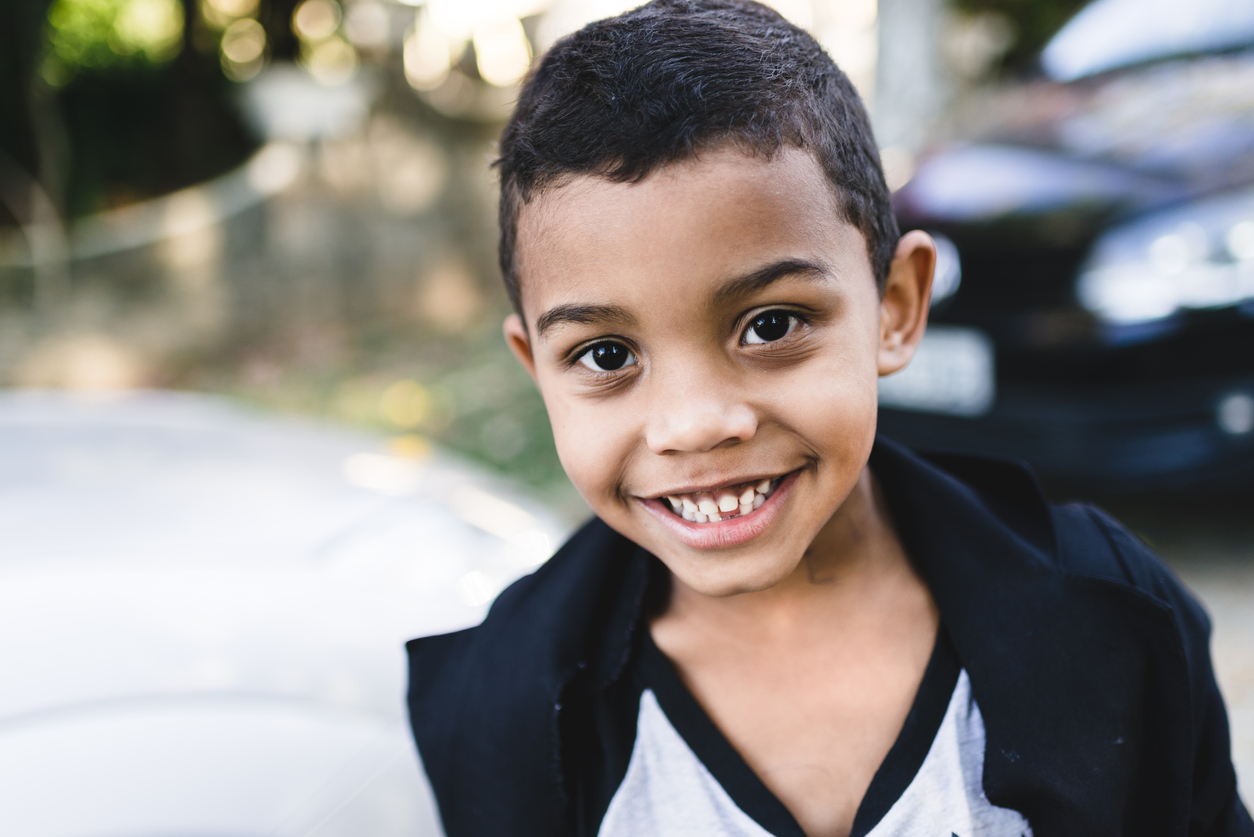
<box><xmin>879</xmin><ymin>230</ymin><xmax>937</xmax><ymax>375</ymax></box>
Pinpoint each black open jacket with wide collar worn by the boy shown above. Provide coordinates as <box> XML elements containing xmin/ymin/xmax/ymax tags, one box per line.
<box><xmin>409</xmin><ymin>439</ymin><xmax>1254</xmax><ymax>837</ymax></box>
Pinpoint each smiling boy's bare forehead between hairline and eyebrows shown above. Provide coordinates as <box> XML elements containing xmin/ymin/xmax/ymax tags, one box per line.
<box><xmin>515</xmin><ymin>148</ymin><xmax>852</xmax><ymax>319</ymax></box>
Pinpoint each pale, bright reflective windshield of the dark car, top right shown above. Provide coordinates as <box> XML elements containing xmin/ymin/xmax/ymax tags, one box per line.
<box><xmin>1041</xmin><ymin>0</ymin><xmax>1254</xmax><ymax>82</ymax></box>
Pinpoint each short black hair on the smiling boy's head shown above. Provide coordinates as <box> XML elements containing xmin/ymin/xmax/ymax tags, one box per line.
<box><xmin>495</xmin><ymin>0</ymin><xmax>899</xmax><ymax>314</ymax></box>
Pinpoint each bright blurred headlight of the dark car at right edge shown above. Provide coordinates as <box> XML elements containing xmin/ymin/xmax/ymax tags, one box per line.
<box><xmin>1076</xmin><ymin>192</ymin><xmax>1254</xmax><ymax>324</ymax></box>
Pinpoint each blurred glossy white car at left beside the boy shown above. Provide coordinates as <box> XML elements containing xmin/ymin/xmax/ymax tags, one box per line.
<box><xmin>0</xmin><ymin>393</ymin><xmax>563</xmax><ymax>837</ymax></box>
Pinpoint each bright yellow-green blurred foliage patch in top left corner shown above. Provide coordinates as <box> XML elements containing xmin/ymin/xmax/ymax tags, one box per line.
<box><xmin>41</xmin><ymin>0</ymin><xmax>184</xmax><ymax>87</ymax></box>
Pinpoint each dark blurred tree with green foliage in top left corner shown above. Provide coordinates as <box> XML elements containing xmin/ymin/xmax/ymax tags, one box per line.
<box><xmin>0</xmin><ymin>0</ymin><xmax>257</xmax><ymax>222</ymax></box>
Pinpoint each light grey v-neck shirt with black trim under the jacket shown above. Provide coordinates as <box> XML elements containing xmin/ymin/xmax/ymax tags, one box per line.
<box><xmin>586</xmin><ymin>627</ymin><xmax>1032</xmax><ymax>837</ymax></box>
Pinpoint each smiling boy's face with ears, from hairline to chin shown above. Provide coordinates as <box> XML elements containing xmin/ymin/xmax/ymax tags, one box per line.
<box><xmin>505</xmin><ymin>148</ymin><xmax>933</xmax><ymax>596</ymax></box>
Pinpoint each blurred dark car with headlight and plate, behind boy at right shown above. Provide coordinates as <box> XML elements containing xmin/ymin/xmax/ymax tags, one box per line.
<box><xmin>880</xmin><ymin>0</ymin><xmax>1254</xmax><ymax>491</ymax></box>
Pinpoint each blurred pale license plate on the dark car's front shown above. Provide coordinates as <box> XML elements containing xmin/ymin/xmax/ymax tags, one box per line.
<box><xmin>879</xmin><ymin>325</ymin><xmax>997</xmax><ymax>415</ymax></box>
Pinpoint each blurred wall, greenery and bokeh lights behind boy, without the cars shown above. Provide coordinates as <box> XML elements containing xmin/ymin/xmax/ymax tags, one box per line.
<box><xmin>0</xmin><ymin>0</ymin><xmax>1098</xmax><ymax>502</ymax></box>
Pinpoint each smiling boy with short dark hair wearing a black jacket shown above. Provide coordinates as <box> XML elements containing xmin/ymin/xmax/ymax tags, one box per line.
<box><xmin>410</xmin><ymin>0</ymin><xmax>1254</xmax><ymax>837</ymax></box>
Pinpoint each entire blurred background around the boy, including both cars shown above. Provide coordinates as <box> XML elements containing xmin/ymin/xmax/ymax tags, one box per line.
<box><xmin>0</xmin><ymin>0</ymin><xmax>1254</xmax><ymax>834</ymax></box>
